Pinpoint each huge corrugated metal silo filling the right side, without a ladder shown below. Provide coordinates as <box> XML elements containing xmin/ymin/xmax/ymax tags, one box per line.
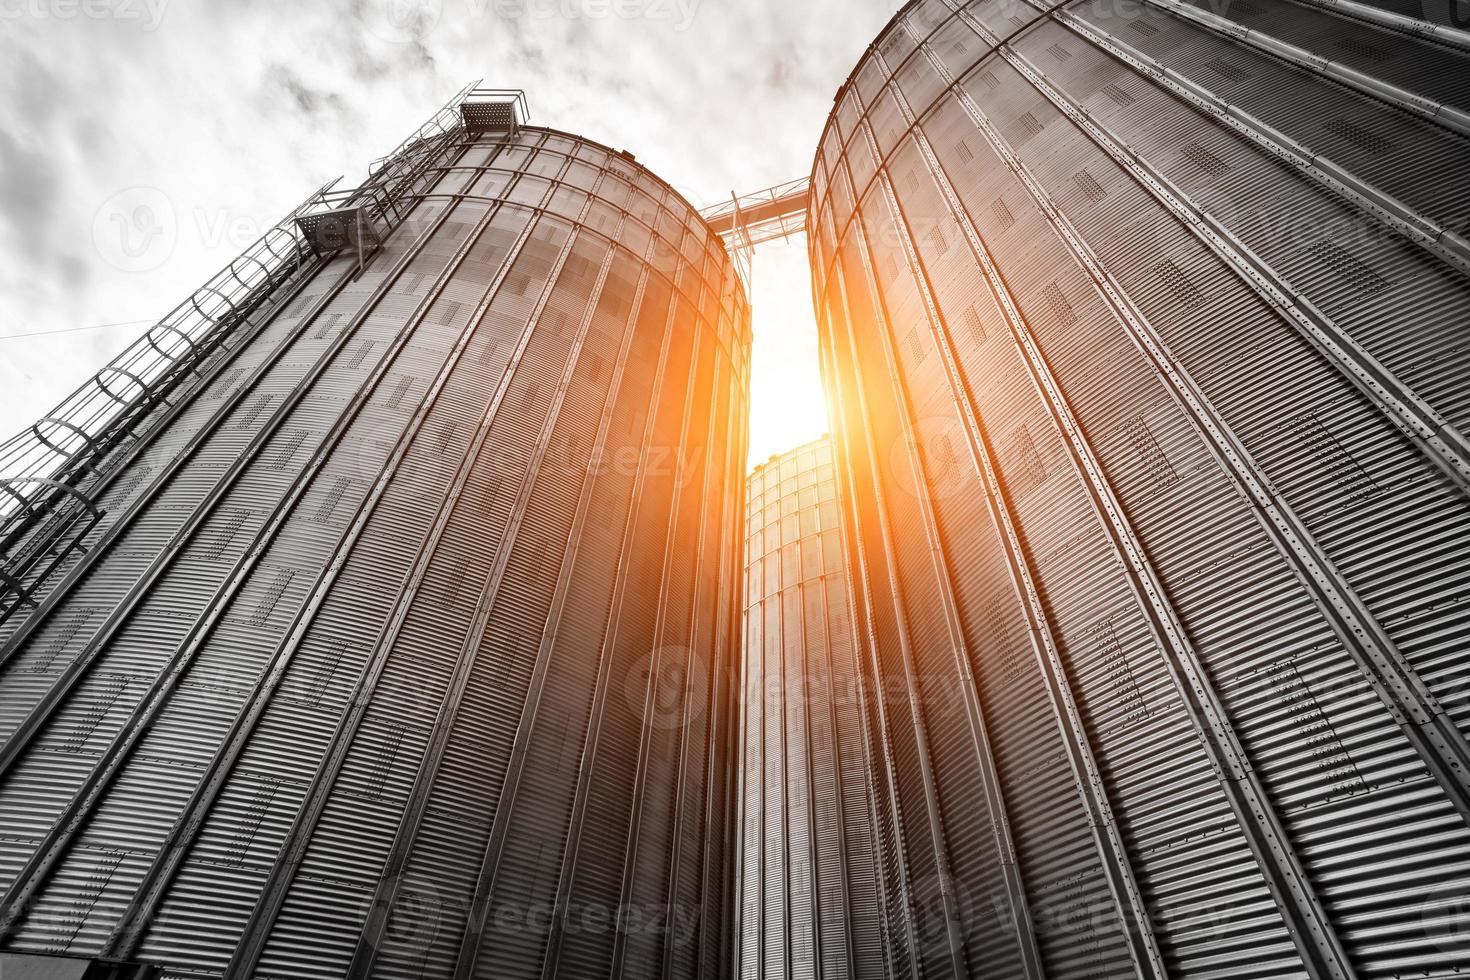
<box><xmin>811</xmin><ymin>0</ymin><xmax>1470</xmax><ymax>979</ymax></box>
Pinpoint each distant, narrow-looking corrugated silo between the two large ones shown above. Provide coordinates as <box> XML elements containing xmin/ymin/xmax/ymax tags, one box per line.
<box><xmin>738</xmin><ymin>439</ymin><xmax>891</xmax><ymax>980</ymax></box>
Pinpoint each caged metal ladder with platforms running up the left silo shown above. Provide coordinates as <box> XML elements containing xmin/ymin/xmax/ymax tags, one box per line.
<box><xmin>0</xmin><ymin>81</ymin><xmax>493</xmax><ymax>623</ymax></box>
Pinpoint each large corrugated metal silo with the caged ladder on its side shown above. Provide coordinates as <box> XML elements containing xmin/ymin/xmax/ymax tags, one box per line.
<box><xmin>0</xmin><ymin>122</ymin><xmax>750</xmax><ymax>977</ymax></box>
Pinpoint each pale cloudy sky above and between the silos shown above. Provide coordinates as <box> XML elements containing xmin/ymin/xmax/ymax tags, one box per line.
<box><xmin>0</xmin><ymin>0</ymin><xmax>900</xmax><ymax>461</ymax></box>
